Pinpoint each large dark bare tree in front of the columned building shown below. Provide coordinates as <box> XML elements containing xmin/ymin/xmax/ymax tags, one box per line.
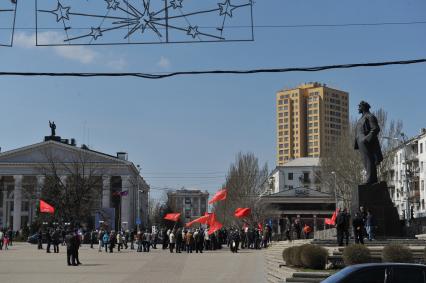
<box><xmin>38</xmin><ymin>146</ymin><xmax>104</xmax><ymax>226</ymax></box>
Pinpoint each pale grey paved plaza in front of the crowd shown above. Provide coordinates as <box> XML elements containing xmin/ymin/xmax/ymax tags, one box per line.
<box><xmin>0</xmin><ymin>243</ymin><xmax>266</xmax><ymax>283</ymax></box>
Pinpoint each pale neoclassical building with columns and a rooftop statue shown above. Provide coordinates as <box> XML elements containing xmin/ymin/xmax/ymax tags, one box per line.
<box><xmin>0</xmin><ymin>136</ymin><xmax>149</xmax><ymax>231</ymax></box>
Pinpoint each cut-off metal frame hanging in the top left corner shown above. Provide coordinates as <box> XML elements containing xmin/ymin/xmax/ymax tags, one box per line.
<box><xmin>0</xmin><ymin>0</ymin><xmax>18</xmax><ymax>47</ymax></box>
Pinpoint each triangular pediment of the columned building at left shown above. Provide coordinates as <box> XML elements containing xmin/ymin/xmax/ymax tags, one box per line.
<box><xmin>0</xmin><ymin>141</ymin><xmax>131</xmax><ymax>165</ymax></box>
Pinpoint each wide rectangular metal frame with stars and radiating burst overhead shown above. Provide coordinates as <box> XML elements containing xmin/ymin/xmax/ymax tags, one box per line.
<box><xmin>35</xmin><ymin>0</ymin><xmax>254</xmax><ymax>46</ymax></box>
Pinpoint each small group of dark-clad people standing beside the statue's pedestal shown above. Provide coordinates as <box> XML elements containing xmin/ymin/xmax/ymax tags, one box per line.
<box><xmin>336</xmin><ymin>206</ymin><xmax>376</xmax><ymax>246</ymax></box>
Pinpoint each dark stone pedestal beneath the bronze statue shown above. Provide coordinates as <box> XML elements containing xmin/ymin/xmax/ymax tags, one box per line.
<box><xmin>351</xmin><ymin>182</ymin><xmax>402</xmax><ymax>237</ymax></box>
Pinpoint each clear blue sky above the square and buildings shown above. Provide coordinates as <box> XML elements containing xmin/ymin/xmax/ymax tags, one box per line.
<box><xmin>0</xmin><ymin>0</ymin><xmax>426</xmax><ymax>200</ymax></box>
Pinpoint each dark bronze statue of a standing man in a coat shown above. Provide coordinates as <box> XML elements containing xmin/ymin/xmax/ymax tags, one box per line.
<box><xmin>355</xmin><ymin>101</ymin><xmax>383</xmax><ymax>185</ymax></box>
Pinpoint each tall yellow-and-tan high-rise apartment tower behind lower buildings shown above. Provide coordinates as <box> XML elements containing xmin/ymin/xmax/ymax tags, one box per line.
<box><xmin>277</xmin><ymin>82</ymin><xmax>349</xmax><ymax>166</ymax></box>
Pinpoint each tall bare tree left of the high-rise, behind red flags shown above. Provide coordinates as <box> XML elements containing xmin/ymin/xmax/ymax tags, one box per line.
<box><xmin>214</xmin><ymin>153</ymin><xmax>269</xmax><ymax>225</ymax></box>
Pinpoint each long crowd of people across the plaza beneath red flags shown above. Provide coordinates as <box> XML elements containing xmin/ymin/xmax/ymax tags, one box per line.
<box><xmin>23</xmin><ymin>225</ymin><xmax>272</xmax><ymax>266</ymax></box>
